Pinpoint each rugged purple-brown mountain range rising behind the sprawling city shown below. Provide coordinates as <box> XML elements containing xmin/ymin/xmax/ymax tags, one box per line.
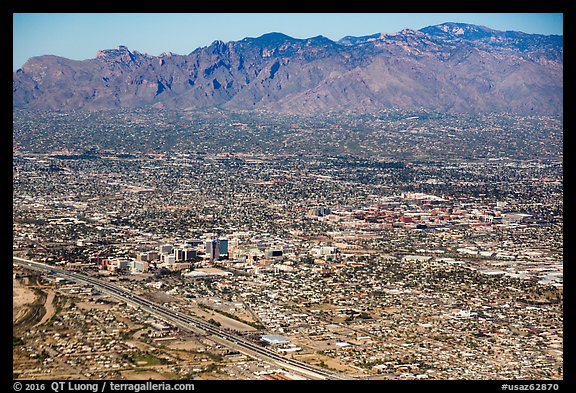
<box><xmin>13</xmin><ymin>23</ymin><xmax>563</xmax><ymax>114</ymax></box>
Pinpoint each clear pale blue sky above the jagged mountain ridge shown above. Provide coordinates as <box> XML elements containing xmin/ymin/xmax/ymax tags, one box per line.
<box><xmin>13</xmin><ymin>13</ymin><xmax>563</xmax><ymax>70</ymax></box>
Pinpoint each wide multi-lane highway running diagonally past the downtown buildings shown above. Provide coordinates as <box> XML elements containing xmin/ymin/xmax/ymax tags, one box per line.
<box><xmin>13</xmin><ymin>257</ymin><xmax>354</xmax><ymax>380</ymax></box>
